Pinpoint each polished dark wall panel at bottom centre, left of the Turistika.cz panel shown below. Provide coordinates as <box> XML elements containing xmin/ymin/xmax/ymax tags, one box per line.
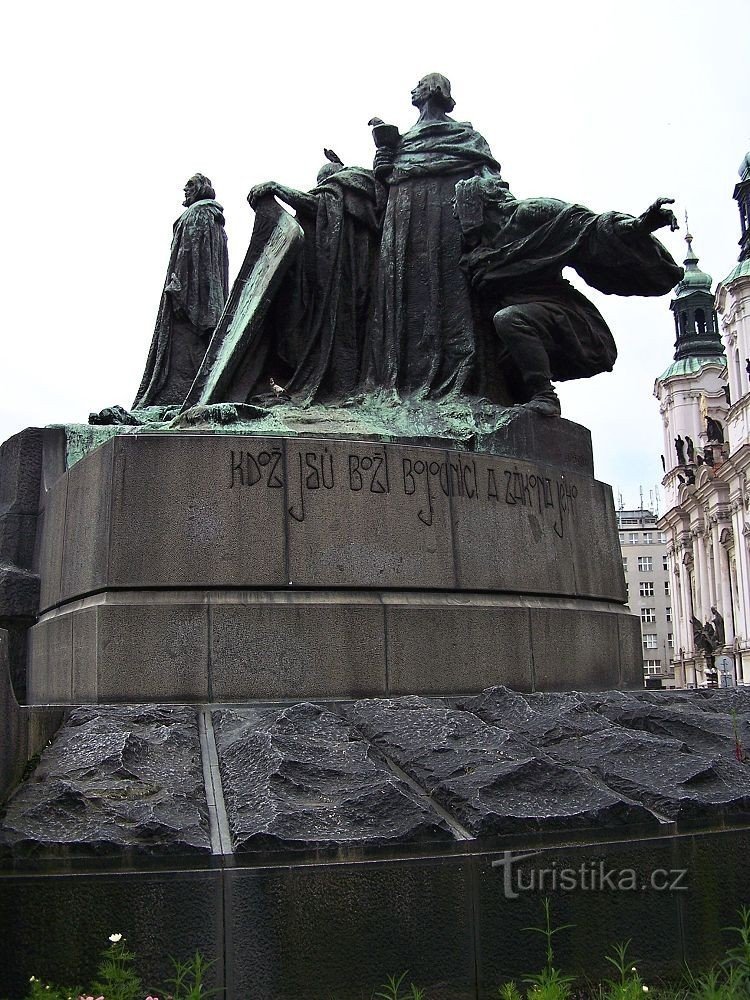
<box><xmin>227</xmin><ymin>858</ymin><xmax>476</xmax><ymax>1000</ymax></box>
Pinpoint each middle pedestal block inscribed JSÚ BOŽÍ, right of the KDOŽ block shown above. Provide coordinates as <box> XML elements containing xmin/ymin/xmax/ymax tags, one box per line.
<box><xmin>286</xmin><ymin>440</ymin><xmax>454</xmax><ymax>588</ymax></box>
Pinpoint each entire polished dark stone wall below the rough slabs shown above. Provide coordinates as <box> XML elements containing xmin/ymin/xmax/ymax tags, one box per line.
<box><xmin>0</xmin><ymin>829</ymin><xmax>750</xmax><ymax>1000</ymax></box>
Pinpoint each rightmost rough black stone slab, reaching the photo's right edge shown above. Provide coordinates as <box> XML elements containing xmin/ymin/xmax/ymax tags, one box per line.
<box><xmin>462</xmin><ymin>688</ymin><xmax>750</xmax><ymax>820</ymax></box>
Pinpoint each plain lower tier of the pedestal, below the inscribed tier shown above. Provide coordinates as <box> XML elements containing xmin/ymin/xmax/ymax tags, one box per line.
<box><xmin>28</xmin><ymin>591</ymin><xmax>643</xmax><ymax>704</ymax></box>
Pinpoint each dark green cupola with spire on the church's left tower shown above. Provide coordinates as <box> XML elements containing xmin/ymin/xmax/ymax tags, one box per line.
<box><xmin>669</xmin><ymin>227</ymin><xmax>724</xmax><ymax>361</ymax></box>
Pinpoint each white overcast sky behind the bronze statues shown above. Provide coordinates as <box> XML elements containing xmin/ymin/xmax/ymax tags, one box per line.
<box><xmin>0</xmin><ymin>0</ymin><xmax>750</xmax><ymax>506</ymax></box>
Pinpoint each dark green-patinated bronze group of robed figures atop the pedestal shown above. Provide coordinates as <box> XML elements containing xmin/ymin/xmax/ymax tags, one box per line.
<box><xmin>135</xmin><ymin>73</ymin><xmax>682</xmax><ymax>416</ymax></box>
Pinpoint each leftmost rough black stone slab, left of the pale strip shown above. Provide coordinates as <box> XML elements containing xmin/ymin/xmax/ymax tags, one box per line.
<box><xmin>0</xmin><ymin>705</ymin><xmax>210</xmax><ymax>858</ymax></box>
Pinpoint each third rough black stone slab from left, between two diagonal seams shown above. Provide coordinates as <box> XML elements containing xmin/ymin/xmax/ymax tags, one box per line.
<box><xmin>349</xmin><ymin>697</ymin><xmax>653</xmax><ymax>837</ymax></box>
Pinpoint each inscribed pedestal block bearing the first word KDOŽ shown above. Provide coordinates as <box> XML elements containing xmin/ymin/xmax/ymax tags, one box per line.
<box><xmin>107</xmin><ymin>434</ymin><xmax>288</xmax><ymax>587</ymax></box>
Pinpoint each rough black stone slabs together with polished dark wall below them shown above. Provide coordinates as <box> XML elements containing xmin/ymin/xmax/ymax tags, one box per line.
<box><xmin>0</xmin><ymin>688</ymin><xmax>750</xmax><ymax>1000</ymax></box>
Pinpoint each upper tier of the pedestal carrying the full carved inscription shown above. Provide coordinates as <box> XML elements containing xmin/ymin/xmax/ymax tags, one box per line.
<box><xmin>36</xmin><ymin>432</ymin><xmax>624</xmax><ymax>610</ymax></box>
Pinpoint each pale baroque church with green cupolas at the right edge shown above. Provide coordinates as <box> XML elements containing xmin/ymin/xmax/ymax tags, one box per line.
<box><xmin>654</xmin><ymin>152</ymin><xmax>750</xmax><ymax>687</ymax></box>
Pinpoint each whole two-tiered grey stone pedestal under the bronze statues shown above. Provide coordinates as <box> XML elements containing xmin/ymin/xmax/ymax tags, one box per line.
<box><xmin>23</xmin><ymin>422</ymin><xmax>642</xmax><ymax>704</ymax></box>
